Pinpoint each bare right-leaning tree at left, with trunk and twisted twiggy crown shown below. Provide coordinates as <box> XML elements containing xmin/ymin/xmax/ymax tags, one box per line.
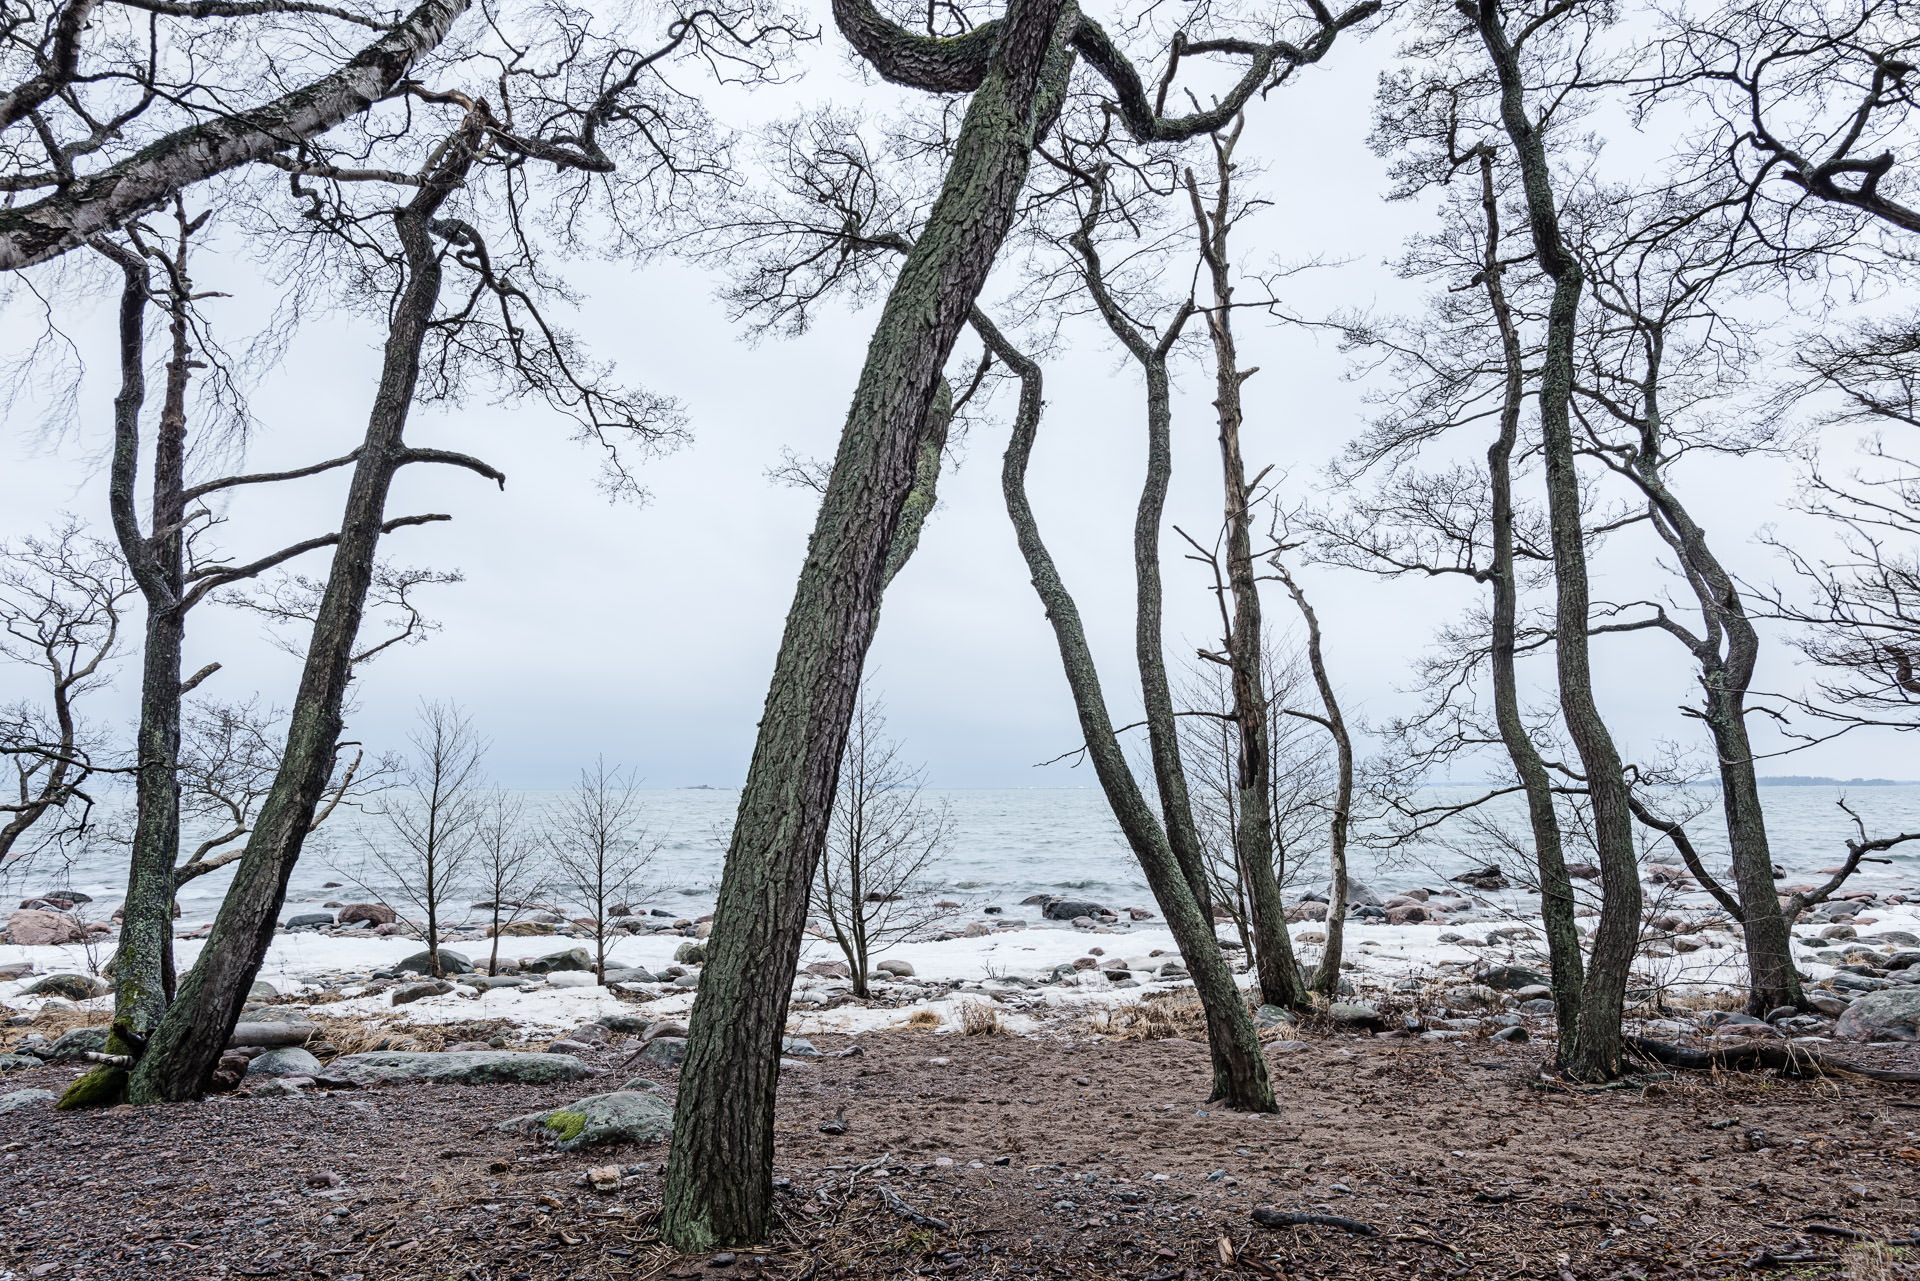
<box><xmin>114</xmin><ymin>6</ymin><xmax>779</xmax><ymax>1102</ymax></box>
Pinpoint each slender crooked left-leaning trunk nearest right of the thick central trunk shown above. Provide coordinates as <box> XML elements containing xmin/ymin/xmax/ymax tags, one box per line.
<box><xmin>973</xmin><ymin>307</ymin><xmax>1277</xmax><ymax>1112</ymax></box>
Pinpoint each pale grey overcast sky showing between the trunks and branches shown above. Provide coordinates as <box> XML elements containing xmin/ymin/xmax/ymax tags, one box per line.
<box><xmin>0</xmin><ymin>6</ymin><xmax>1896</xmax><ymax>787</ymax></box>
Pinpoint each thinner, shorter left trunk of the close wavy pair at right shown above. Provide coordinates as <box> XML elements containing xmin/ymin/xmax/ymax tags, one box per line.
<box><xmin>1480</xmin><ymin>150</ymin><xmax>1586</xmax><ymax>1062</ymax></box>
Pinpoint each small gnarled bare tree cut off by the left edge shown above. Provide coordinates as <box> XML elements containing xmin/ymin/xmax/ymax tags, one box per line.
<box><xmin>0</xmin><ymin>520</ymin><xmax>134</xmax><ymax>866</ymax></box>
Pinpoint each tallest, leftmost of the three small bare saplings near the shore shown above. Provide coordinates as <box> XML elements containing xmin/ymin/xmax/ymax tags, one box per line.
<box><xmin>359</xmin><ymin>703</ymin><xmax>488</xmax><ymax>978</ymax></box>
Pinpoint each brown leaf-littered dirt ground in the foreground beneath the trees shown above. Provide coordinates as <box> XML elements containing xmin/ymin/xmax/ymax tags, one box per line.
<box><xmin>0</xmin><ymin>1031</ymin><xmax>1920</xmax><ymax>1281</ymax></box>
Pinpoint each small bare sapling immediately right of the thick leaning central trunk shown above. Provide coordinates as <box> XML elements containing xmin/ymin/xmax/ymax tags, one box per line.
<box><xmin>812</xmin><ymin>678</ymin><xmax>954</xmax><ymax>999</ymax></box>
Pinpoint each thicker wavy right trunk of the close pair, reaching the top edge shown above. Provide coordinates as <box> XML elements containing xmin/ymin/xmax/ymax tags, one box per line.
<box><xmin>1463</xmin><ymin>0</ymin><xmax>1642</xmax><ymax>1081</ymax></box>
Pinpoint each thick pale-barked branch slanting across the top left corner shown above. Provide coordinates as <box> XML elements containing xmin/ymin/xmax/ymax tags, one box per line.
<box><xmin>0</xmin><ymin>0</ymin><xmax>470</xmax><ymax>271</ymax></box>
